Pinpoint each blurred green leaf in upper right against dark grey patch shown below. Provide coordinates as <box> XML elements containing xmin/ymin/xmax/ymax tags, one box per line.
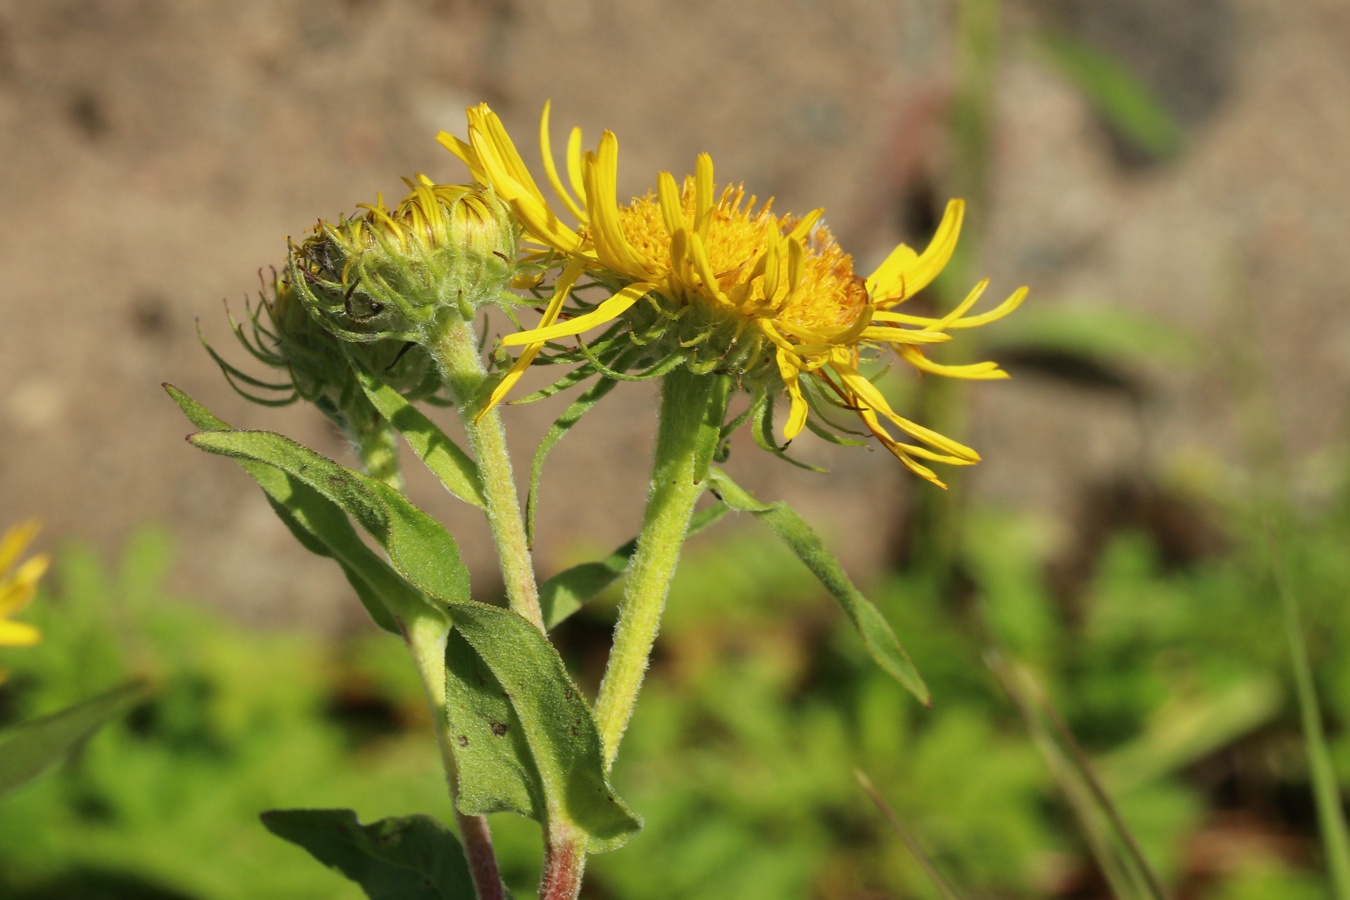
<box><xmin>1040</xmin><ymin>34</ymin><xmax>1185</xmax><ymax>159</ymax></box>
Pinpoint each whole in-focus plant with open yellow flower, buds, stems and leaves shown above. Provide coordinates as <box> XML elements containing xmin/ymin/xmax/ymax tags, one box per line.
<box><xmin>169</xmin><ymin>105</ymin><xmax>1026</xmax><ymax>900</ymax></box>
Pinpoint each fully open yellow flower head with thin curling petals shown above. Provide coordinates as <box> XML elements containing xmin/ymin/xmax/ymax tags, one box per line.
<box><xmin>439</xmin><ymin>104</ymin><xmax>1026</xmax><ymax>484</ymax></box>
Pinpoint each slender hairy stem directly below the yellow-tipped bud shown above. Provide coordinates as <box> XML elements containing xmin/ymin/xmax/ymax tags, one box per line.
<box><xmin>432</xmin><ymin>318</ymin><xmax>544</xmax><ymax>631</ymax></box>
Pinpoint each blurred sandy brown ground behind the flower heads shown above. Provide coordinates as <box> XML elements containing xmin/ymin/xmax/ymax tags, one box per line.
<box><xmin>0</xmin><ymin>0</ymin><xmax>1350</xmax><ymax>627</ymax></box>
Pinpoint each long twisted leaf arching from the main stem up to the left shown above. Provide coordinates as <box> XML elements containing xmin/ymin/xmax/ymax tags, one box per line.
<box><xmin>190</xmin><ymin>423</ymin><xmax>641</xmax><ymax>853</ymax></box>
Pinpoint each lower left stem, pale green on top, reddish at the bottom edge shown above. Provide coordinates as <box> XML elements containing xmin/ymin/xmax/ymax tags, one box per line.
<box><xmin>404</xmin><ymin>611</ymin><xmax>506</xmax><ymax>900</ymax></box>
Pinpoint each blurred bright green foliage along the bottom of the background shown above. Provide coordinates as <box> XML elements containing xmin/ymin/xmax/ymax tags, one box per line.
<box><xmin>0</xmin><ymin>483</ymin><xmax>1350</xmax><ymax>900</ymax></box>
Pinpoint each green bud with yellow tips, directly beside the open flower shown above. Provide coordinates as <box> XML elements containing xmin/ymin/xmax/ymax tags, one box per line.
<box><xmin>290</xmin><ymin>175</ymin><xmax>520</xmax><ymax>344</ymax></box>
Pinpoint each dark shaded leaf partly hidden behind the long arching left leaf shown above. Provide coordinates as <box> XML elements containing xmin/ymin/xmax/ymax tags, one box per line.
<box><xmin>165</xmin><ymin>385</ymin><xmax>407</xmax><ymax>634</ymax></box>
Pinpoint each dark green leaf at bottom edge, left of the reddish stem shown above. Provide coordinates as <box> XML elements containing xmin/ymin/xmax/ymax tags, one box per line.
<box><xmin>261</xmin><ymin>810</ymin><xmax>477</xmax><ymax>900</ymax></box>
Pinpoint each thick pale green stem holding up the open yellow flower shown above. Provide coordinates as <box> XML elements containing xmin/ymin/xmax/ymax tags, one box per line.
<box><xmin>595</xmin><ymin>367</ymin><xmax>730</xmax><ymax>766</ymax></box>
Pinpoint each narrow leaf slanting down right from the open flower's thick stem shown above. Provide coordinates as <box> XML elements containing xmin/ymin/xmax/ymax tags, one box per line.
<box><xmin>709</xmin><ymin>468</ymin><xmax>930</xmax><ymax>706</ymax></box>
